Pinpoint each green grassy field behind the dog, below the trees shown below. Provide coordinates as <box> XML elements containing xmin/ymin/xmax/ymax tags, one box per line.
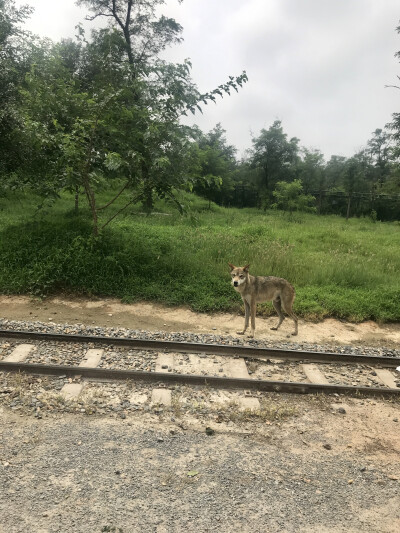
<box><xmin>0</xmin><ymin>187</ymin><xmax>400</xmax><ymax>322</ymax></box>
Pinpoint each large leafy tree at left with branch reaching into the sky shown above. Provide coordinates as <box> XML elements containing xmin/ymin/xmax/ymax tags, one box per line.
<box><xmin>18</xmin><ymin>0</ymin><xmax>247</xmax><ymax>235</ymax></box>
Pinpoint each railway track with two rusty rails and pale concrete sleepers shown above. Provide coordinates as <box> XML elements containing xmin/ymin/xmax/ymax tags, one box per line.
<box><xmin>0</xmin><ymin>330</ymin><xmax>400</xmax><ymax>407</ymax></box>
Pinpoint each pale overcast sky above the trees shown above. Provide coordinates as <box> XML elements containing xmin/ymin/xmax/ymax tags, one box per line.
<box><xmin>17</xmin><ymin>0</ymin><xmax>400</xmax><ymax>159</ymax></box>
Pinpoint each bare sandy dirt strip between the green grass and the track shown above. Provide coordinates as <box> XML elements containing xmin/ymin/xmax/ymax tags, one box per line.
<box><xmin>0</xmin><ymin>296</ymin><xmax>400</xmax><ymax>346</ymax></box>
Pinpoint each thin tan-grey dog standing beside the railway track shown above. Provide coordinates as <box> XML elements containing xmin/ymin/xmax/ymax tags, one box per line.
<box><xmin>228</xmin><ymin>263</ymin><xmax>298</xmax><ymax>338</ymax></box>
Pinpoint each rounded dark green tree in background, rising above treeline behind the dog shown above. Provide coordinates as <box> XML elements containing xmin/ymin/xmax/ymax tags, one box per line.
<box><xmin>250</xmin><ymin>120</ymin><xmax>299</xmax><ymax>202</ymax></box>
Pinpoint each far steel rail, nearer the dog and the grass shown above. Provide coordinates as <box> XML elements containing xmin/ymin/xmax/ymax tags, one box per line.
<box><xmin>0</xmin><ymin>330</ymin><xmax>400</xmax><ymax>368</ymax></box>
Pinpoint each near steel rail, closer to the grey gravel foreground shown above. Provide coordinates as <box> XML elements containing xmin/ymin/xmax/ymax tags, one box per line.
<box><xmin>0</xmin><ymin>361</ymin><xmax>400</xmax><ymax>396</ymax></box>
